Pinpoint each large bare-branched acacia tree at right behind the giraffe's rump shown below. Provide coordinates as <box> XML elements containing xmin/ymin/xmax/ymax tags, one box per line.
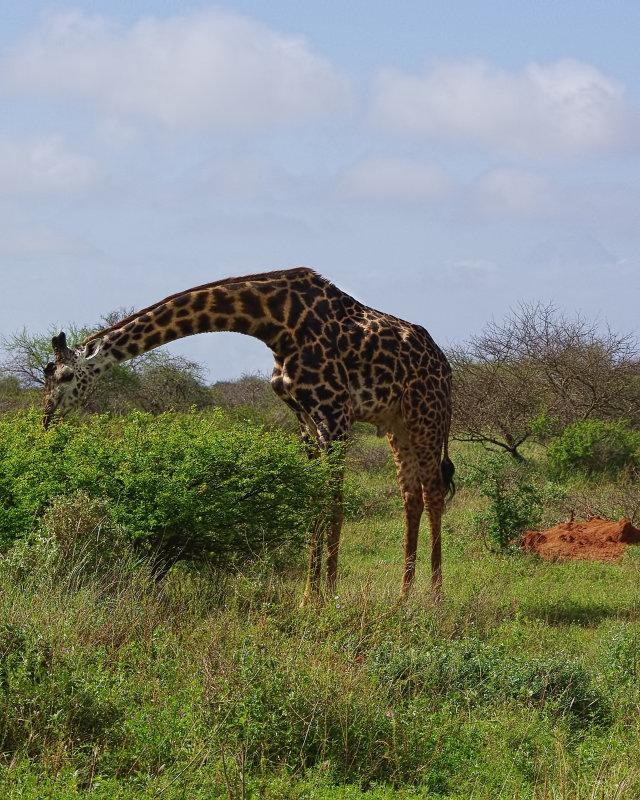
<box><xmin>450</xmin><ymin>303</ymin><xmax>640</xmax><ymax>458</ymax></box>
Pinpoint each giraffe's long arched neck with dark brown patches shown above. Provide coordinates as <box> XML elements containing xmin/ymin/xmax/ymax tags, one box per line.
<box><xmin>83</xmin><ymin>269</ymin><xmax>315</xmax><ymax>363</ymax></box>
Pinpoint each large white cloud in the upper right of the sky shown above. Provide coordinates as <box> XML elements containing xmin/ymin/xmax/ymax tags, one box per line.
<box><xmin>372</xmin><ymin>59</ymin><xmax>639</xmax><ymax>159</ymax></box>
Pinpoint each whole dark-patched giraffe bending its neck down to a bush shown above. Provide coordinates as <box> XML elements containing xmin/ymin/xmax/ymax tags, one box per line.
<box><xmin>43</xmin><ymin>267</ymin><xmax>454</xmax><ymax>604</ymax></box>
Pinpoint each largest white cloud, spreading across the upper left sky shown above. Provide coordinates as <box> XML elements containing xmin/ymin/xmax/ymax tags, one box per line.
<box><xmin>0</xmin><ymin>10</ymin><xmax>349</xmax><ymax>130</ymax></box>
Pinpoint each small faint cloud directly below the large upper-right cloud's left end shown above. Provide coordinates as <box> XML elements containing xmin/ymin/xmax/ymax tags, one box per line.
<box><xmin>341</xmin><ymin>157</ymin><xmax>452</xmax><ymax>202</ymax></box>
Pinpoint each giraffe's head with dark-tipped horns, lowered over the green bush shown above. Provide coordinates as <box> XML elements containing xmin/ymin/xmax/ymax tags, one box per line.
<box><xmin>42</xmin><ymin>333</ymin><xmax>102</xmax><ymax>428</ymax></box>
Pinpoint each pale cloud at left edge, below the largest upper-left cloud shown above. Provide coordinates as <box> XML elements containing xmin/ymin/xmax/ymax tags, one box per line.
<box><xmin>0</xmin><ymin>136</ymin><xmax>98</xmax><ymax>197</ymax></box>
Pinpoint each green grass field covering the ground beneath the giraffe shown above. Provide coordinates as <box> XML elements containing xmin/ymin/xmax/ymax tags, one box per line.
<box><xmin>0</xmin><ymin>422</ymin><xmax>640</xmax><ymax>800</ymax></box>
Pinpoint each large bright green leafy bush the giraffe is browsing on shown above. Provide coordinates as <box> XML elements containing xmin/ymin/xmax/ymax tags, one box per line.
<box><xmin>0</xmin><ymin>412</ymin><xmax>327</xmax><ymax>569</ymax></box>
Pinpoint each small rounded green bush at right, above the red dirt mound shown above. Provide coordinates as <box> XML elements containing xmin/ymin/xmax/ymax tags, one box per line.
<box><xmin>547</xmin><ymin>420</ymin><xmax>640</xmax><ymax>480</ymax></box>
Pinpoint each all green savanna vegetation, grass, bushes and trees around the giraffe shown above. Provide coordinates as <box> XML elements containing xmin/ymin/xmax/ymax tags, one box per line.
<box><xmin>0</xmin><ymin>307</ymin><xmax>640</xmax><ymax>800</ymax></box>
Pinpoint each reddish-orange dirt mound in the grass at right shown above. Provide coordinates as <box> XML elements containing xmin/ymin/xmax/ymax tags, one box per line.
<box><xmin>520</xmin><ymin>517</ymin><xmax>640</xmax><ymax>561</ymax></box>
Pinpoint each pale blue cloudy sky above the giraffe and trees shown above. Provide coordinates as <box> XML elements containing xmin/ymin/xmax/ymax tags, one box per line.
<box><xmin>0</xmin><ymin>0</ymin><xmax>640</xmax><ymax>381</ymax></box>
